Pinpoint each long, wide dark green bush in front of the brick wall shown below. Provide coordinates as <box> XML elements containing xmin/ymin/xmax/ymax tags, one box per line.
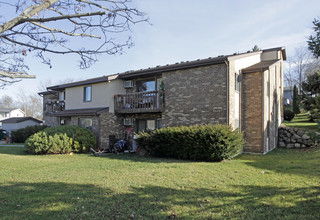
<box><xmin>136</xmin><ymin>125</ymin><xmax>244</xmax><ymax>161</ymax></box>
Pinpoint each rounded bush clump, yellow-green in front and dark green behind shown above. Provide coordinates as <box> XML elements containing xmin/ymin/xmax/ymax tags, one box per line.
<box><xmin>25</xmin><ymin>125</ymin><xmax>96</xmax><ymax>154</ymax></box>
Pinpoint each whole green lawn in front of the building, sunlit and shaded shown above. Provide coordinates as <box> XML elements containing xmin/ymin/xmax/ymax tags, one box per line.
<box><xmin>0</xmin><ymin>146</ymin><xmax>320</xmax><ymax>219</ymax></box>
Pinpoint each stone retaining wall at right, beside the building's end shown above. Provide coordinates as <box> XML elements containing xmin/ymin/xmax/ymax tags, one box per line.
<box><xmin>278</xmin><ymin>127</ymin><xmax>315</xmax><ymax>148</ymax></box>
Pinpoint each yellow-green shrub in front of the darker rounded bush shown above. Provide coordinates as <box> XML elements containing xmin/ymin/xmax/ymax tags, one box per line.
<box><xmin>25</xmin><ymin>131</ymin><xmax>72</xmax><ymax>154</ymax></box>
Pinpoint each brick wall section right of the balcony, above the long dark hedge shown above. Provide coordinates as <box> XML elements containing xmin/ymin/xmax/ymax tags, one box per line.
<box><xmin>162</xmin><ymin>64</ymin><xmax>227</xmax><ymax>127</ymax></box>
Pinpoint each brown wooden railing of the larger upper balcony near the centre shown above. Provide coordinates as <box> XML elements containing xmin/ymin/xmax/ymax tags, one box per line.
<box><xmin>114</xmin><ymin>91</ymin><xmax>164</xmax><ymax>114</ymax></box>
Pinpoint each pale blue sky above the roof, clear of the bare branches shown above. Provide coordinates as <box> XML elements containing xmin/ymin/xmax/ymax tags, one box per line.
<box><xmin>0</xmin><ymin>0</ymin><xmax>320</xmax><ymax>97</ymax></box>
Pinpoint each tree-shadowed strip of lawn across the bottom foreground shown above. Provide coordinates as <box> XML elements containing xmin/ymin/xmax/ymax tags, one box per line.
<box><xmin>0</xmin><ymin>182</ymin><xmax>320</xmax><ymax>219</ymax></box>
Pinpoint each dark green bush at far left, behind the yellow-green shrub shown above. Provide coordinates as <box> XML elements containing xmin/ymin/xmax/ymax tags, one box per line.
<box><xmin>11</xmin><ymin>125</ymin><xmax>48</xmax><ymax>143</ymax></box>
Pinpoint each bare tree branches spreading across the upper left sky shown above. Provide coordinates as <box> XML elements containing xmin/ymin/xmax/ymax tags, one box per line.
<box><xmin>0</xmin><ymin>0</ymin><xmax>147</xmax><ymax>87</ymax></box>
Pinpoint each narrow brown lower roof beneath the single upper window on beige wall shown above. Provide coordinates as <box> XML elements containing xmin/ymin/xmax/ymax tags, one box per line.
<box><xmin>48</xmin><ymin>107</ymin><xmax>109</xmax><ymax>117</ymax></box>
